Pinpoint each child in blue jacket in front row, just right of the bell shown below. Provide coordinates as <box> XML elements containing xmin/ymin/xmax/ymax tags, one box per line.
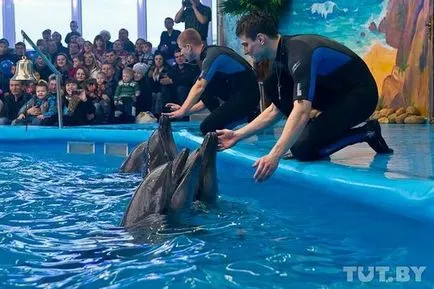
<box><xmin>12</xmin><ymin>80</ymin><xmax>56</xmax><ymax>125</ymax></box>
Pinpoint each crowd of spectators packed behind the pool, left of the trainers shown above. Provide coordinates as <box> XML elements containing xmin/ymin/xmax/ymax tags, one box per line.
<box><xmin>0</xmin><ymin>6</ymin><xmax>215</xmax><ymax>125</ymax></box>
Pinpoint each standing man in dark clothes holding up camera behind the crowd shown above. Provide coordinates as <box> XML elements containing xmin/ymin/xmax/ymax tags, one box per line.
<box><xmin>175</xmin><ymin>0</ymin><xmax>211</xmax><ymax>45</ymax></box>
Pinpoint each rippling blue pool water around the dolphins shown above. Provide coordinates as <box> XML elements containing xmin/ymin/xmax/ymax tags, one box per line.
<box><xmin>0</xmin><ymin>142</ymin><xmax>434</xmax><ymax>289</ymax></box>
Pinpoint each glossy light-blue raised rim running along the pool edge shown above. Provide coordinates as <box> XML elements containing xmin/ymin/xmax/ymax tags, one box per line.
<box><xmin>0</xmin><ymin>124</ymin><xmax>434</xmax><ymax>223</ymax></box>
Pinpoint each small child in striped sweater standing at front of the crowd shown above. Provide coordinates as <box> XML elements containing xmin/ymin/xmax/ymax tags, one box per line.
<box><xmin>114</xmin><ymin>67</ymin><xmax>140</xmax><ymax>122</ymax></box>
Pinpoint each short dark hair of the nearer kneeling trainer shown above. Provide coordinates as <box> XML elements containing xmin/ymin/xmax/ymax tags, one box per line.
<box><xmin>236</xmin><ymin>11</ymin><xmax>278</xmax><ymax>40</ymax></box>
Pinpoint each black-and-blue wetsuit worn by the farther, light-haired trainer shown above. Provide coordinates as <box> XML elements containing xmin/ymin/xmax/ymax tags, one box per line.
<box><xmin>199</xmin><ymin>46</ymin><xmax>259</xmax><ymax>134</ymax></box>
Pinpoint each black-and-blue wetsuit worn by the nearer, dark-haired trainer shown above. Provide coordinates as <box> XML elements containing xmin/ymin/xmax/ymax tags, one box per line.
<box><xmin>264</xmin><ymin>35</ymin><xmax>378</xmax><ymax>161</ymax></box>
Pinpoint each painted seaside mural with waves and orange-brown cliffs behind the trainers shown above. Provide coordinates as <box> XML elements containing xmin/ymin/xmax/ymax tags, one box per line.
<box><xmin>224</xmin><ymin>0</ymin><xmax>433</xmax><ymax>115</ymax></box>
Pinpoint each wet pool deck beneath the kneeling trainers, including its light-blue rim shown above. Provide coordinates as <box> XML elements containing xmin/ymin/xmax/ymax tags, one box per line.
<box><xmin>0</xmin><ymin>122</ymin><xmax>434</xmax><ymax>222</ymax></box>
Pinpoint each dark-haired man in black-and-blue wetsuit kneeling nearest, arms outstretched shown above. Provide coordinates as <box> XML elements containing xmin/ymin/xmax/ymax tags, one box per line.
<box><xmin>217</xmin><ymin>13</ymin><xmax>393</xmax><ymax>181</ymax></box>
